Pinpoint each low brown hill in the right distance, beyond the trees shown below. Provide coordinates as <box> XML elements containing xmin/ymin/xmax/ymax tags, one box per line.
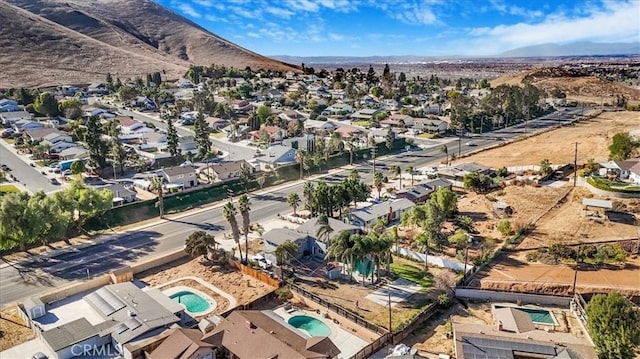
<box><xmin>491</xmin><ymin>67</ymin><xmax>640</xmax><ymax>102</ymax></box>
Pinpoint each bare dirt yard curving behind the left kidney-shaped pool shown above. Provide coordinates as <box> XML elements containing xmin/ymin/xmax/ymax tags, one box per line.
<box><xmin>136</xmin><ymin>258</ymin><xmax>275</xmax><ymax>311</ymax></box>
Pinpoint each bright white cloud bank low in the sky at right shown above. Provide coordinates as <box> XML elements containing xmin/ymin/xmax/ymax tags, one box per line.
<box><xmin>466</xmin><ymin>0</ymin><xmax>640</xmax><ymax>54</ymax></box>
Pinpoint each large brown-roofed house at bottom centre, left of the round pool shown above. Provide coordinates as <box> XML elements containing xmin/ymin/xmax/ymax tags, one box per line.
<box><xmin>202</xmin><ymin>310</ymin><xmax>340</xmax><ymax>359</ymax></box>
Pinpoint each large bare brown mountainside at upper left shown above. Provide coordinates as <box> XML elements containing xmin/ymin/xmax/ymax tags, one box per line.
<box><xmin>0</xmin><ymin>0</ymin><xmax>296</xmax><ymax>87</ymax></box>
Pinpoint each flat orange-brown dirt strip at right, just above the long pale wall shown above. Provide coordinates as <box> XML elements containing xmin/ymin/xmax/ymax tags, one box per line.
<box><xmin>471</xmin><ymin>252</ymin><xmax>640</xmax><ymax>296</ymax></box>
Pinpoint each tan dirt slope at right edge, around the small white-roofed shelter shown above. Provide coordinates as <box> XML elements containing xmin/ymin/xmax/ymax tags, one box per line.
<box><xmin>518</xmin><ymin>188</ymin><xmax>640</xmax><ymax>249</ymax></box>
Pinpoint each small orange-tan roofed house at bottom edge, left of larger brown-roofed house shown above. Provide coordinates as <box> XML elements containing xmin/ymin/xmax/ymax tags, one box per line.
<box><xmin>148</xmin><ymin>328</ymin><xmax>216</xmax><ymax>359</ymax></box>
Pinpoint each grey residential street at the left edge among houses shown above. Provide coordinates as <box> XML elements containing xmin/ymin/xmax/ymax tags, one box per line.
<box><xmin>0</xmin><ymin>140</ymin><xmax>61</xmax><ymax>192</ymax></box>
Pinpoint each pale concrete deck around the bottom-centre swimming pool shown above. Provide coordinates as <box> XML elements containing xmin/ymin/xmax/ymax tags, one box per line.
<box><xmin>273</xmin><ymin>306</ymin><xmax>369</xmax><ymax>358</ymax></box>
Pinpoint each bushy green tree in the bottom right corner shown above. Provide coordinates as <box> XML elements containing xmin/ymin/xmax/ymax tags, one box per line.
<box><xmin>586</xmin><ymin>292</ymin><xmax>640</xmax><ymax>359</ymax></box>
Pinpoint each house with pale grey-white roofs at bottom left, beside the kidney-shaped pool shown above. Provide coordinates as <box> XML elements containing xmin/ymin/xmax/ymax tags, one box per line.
<box><xmin>34</xmin><ymin>282</ymin><xmax>182</xmax><ymax>359</ymax></box>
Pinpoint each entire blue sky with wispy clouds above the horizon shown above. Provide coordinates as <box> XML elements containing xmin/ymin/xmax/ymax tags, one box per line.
<box><xmin>156</xmin><ymin>0</ymin><xmax>640</xmax><ymax>56</ymax></box>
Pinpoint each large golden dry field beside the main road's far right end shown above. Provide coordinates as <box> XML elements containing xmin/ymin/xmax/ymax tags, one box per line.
<box><xmin>458</xmin><ymin>111</ymin><xmax>640</xmax><ymax>168</ymax></box>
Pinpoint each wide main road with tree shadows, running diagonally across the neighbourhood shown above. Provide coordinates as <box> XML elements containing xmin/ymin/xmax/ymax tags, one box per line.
<box><xmin>0</xmin><ymin>107</ymin><xmax>584</xmax><ymax>305</ymax></box>
